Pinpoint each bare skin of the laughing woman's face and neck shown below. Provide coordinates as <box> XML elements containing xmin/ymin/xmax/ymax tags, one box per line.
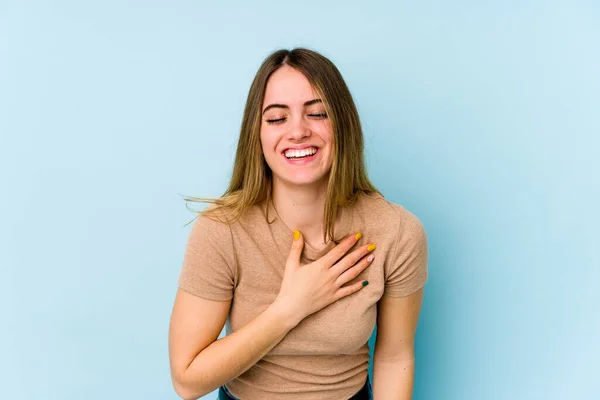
<box><xmin>260</xmin><ymin>66</ymin><xmax>333</xmax><ymax>249</ymax></box>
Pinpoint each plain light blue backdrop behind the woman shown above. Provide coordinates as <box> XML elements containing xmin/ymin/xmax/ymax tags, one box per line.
<box><xmin>0</xmin><ymin>0</ymin><xmax>600</xmax><ymax>400</ymax></box>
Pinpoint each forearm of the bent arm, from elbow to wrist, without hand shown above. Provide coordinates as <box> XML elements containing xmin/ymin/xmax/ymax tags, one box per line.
<box><xmin>176</xmin><ymin>303</ymin><xmax>300</xmax><ymax>399</ymax></box>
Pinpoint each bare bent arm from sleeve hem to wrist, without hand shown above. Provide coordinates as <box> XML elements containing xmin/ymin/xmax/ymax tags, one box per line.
<box><xmin>169</xmin><ymin>289</ymin><xmax>299</xmax><ymax>399</ymax></box>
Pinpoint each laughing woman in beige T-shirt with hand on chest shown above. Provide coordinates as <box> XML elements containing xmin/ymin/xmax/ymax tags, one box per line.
<box><xmin>169</xmin><ymin>49</ymin><xmax>427</xmax><ymax>400</ymax></box>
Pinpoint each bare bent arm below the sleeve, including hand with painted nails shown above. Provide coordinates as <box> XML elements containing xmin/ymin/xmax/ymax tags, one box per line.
<box><xmin>169</xmin><ymin>230</ymin><xmax>372</xmax><ymax>399</ymax></box>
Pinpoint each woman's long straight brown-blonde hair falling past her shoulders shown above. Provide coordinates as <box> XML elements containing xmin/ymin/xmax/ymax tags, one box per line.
<box><xmin>185</xmin><ymin>48</ymin><xmax>380</xmax><ymax>241</ymax></box>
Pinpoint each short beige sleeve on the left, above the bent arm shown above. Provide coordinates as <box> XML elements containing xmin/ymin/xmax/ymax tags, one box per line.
<box><xmin>178</xmin><ymin>215</ymin><xmax>235</xmax><ymax>301</ymax></box>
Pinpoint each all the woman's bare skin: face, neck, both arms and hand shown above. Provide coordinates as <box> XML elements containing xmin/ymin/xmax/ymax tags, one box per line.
<box><xmin>169</xmin><ymin>67</ymin><xmax>420</xmax><ymax>399</ymax></box>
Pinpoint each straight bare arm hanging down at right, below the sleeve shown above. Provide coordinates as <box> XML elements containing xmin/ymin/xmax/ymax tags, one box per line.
<box><xmin>373</xmin><ymin>288</ymin><xmax>423</xmax><ymax>400</ymax></box>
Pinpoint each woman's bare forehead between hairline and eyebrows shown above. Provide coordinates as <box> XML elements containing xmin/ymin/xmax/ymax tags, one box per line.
<box><xmin>264</xmin><ymin>65</ymin><xmax>318</xmax><ymax>105</ymax></box>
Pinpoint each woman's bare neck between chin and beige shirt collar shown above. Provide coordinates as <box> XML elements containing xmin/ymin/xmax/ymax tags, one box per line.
<box><xmin>272</xmin><ymin>177</ymin><xmax>327</xmax><ymax>248</ymax></box>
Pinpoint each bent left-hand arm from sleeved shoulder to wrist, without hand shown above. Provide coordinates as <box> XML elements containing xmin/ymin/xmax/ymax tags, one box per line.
<box><xmin>169</xmin><ymin>211</ymin><xmax>295</xmax><ymax>399</ymax></box>
